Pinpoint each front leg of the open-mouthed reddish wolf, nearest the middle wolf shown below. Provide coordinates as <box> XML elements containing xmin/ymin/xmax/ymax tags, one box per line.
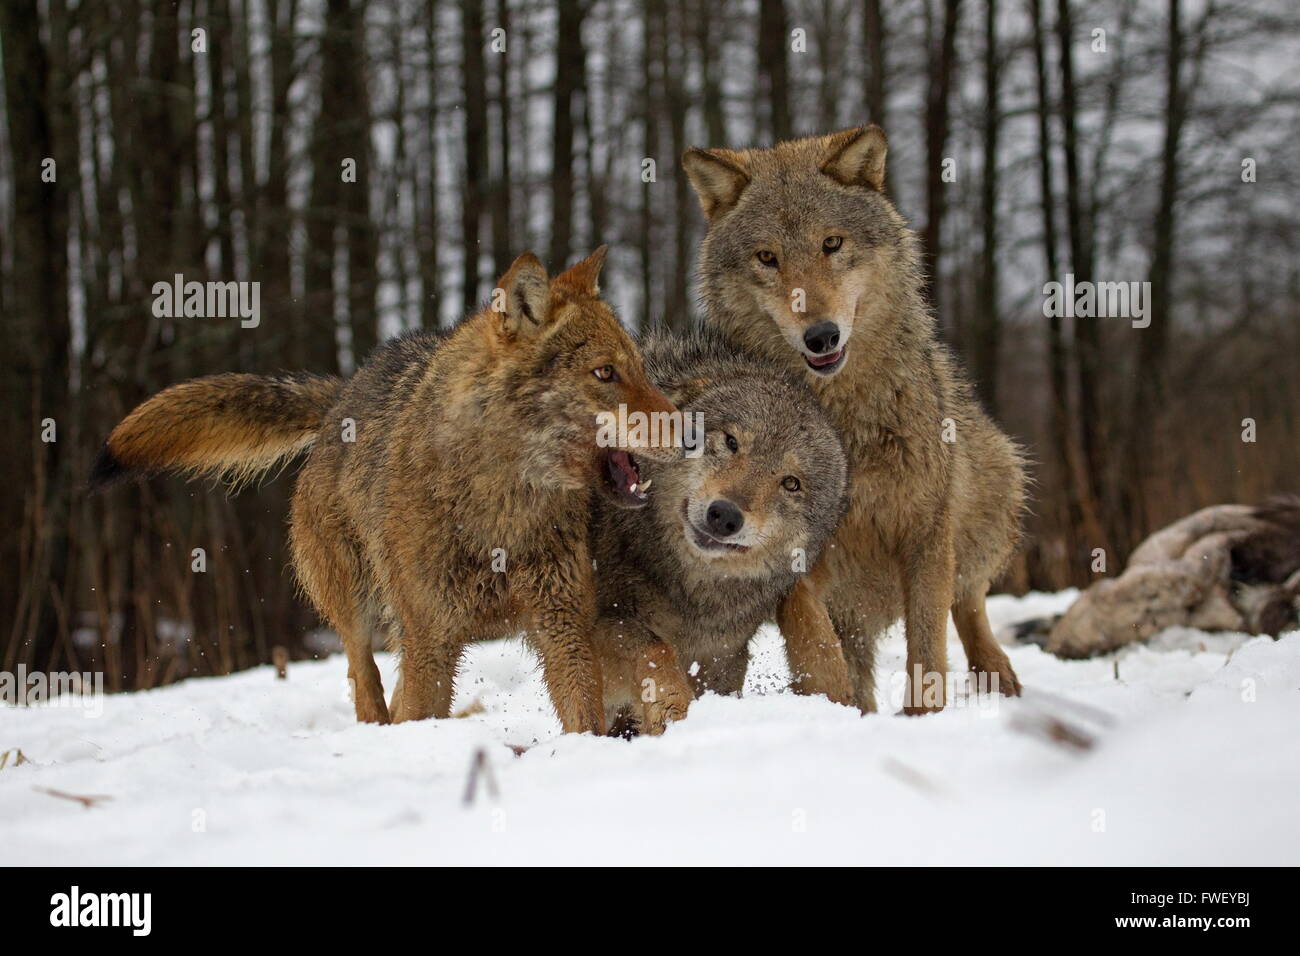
<box><xmin>516</xmin><ymin>549</ymin><xmax>606</xmax><ymax>734</ymax></box>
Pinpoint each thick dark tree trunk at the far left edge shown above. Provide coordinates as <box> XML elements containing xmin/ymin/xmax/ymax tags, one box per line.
<box><xmin>0</xmin><ymin>0</ymin><xmax>77</xmax><ymax>671</ymax></box>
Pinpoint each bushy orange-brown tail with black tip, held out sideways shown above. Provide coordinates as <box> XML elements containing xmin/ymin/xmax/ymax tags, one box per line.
<box><xmin>90</xmin><ymin>372</ymin><xmax>343</xmax><ymax>490</ymax></box>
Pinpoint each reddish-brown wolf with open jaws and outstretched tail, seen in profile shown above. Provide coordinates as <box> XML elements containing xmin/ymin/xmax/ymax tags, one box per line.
<box><xmin>92</xmin><ymin>247</ymin><xmax>677</xmax><ymax>732</ymax></box>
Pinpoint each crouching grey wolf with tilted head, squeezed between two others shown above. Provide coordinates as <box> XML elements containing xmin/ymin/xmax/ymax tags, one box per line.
<box><xmin>590</xmin><ymin>332</ymin><xmax>848</xmax><ymax>734</ymax></box>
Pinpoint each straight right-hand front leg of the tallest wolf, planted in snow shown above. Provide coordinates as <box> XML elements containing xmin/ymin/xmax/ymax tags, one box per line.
<box><xmin>898</xmin><ymin>514</ymin><xmax>956</xmax><ymax>714</ymax></box>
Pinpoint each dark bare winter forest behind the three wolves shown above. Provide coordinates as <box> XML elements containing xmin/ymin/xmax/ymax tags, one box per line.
<box><xmin>0</xmin><ymin>0</ymin><xmax>1300</xmax><ymax>689</ymax></box>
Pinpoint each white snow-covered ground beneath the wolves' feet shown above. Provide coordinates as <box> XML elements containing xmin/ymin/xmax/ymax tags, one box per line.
<box><xmin>0</xmin><ymin>593</ymin><xmax>1300</xmax><ymax>865</ymax></box>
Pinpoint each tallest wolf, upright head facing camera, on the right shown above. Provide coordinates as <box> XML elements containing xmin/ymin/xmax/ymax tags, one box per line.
<box><xmin>683</xmin><ymin>126</ymin><xmax>1024</xmax><ymax>713</ymax></box>
